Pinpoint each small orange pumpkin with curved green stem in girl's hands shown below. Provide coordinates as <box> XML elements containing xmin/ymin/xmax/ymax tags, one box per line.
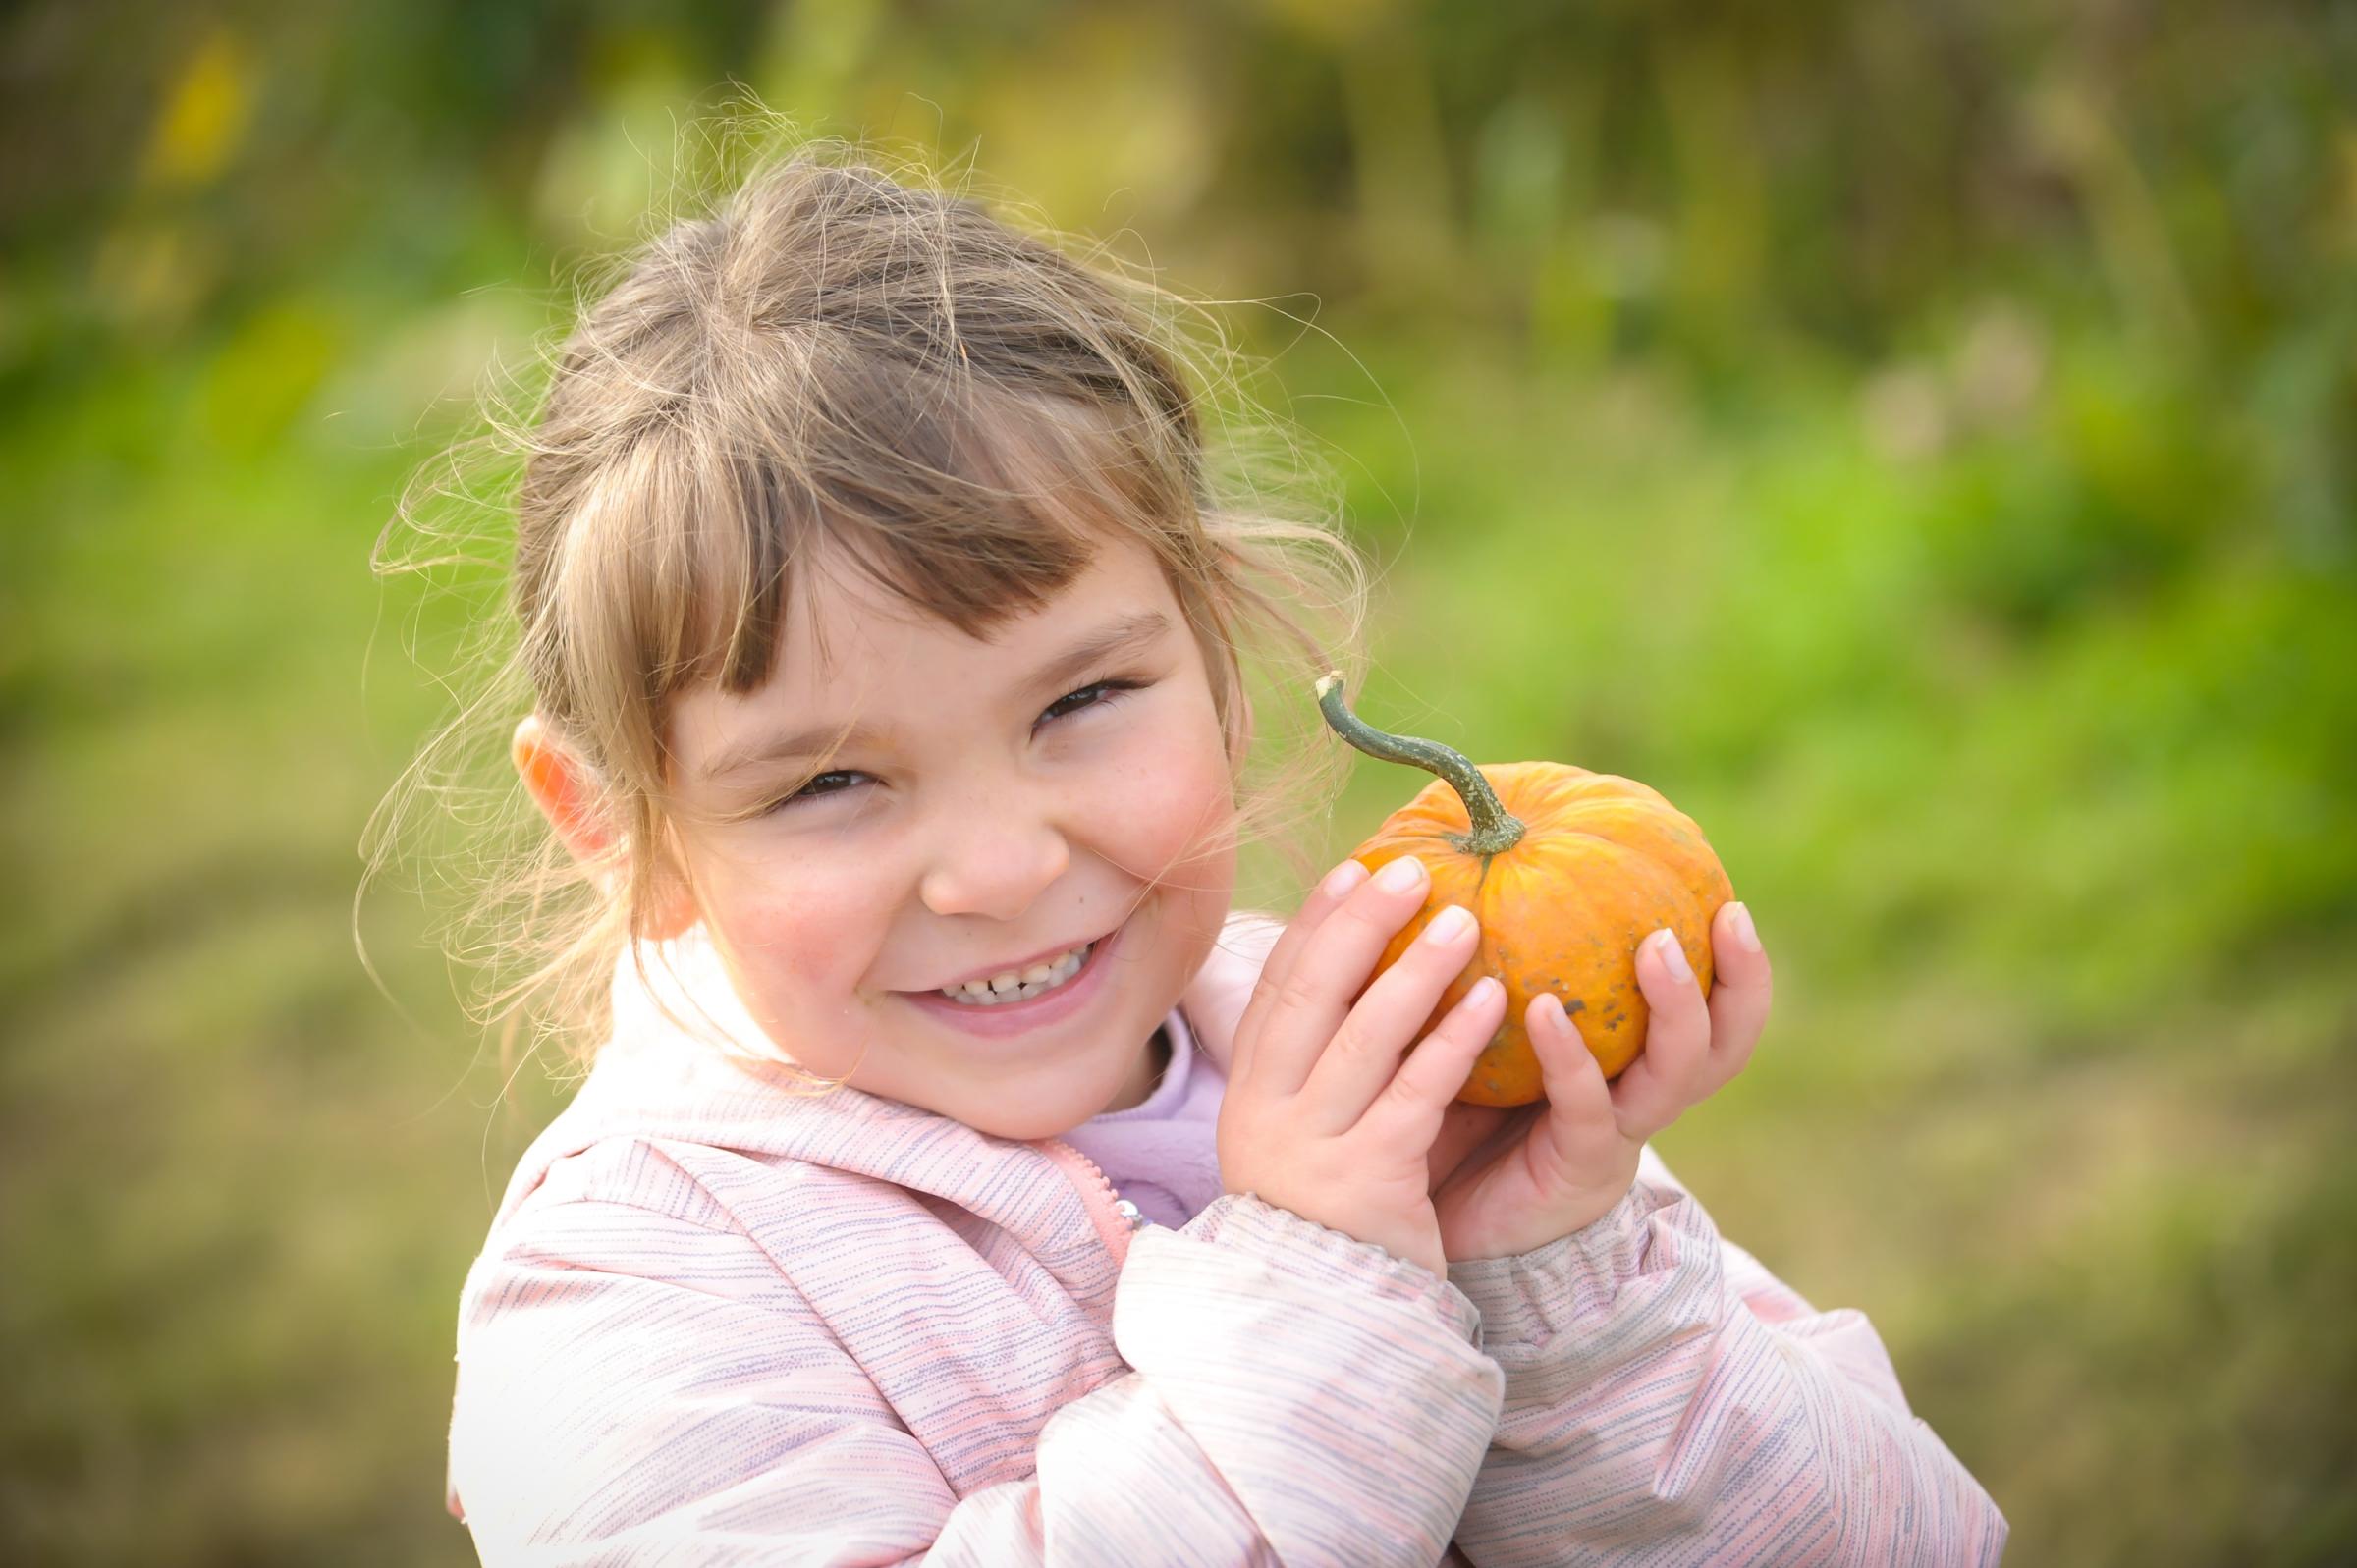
<box><xmin>1318</xmin><ymin>675</ymin><xmax>1734</xmax><ymax>1106</ymax></box>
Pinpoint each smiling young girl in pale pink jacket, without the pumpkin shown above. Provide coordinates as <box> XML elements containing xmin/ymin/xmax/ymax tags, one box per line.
<box><xmin>428</xmin><ymin>151</ymin><xmax>2005</xmax><ymax>1568</ymax></box>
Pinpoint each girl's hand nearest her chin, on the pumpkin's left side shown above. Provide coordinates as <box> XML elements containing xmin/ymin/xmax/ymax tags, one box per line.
<box><xmin>1219</xmin><ymin>856</ymin><xmax>1507</xmax><ymax>1273</ymax></box>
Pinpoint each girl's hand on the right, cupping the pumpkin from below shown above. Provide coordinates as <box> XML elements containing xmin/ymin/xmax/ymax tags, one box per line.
<box><xmin>1428</xmin><ymin>903</ymin><xmax>1775</xmax><ymax>1262</ymax></box>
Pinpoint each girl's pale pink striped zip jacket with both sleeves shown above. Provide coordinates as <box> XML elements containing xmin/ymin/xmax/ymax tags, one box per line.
<box><xmin>450</xmin><ymin>917</ymin><xmax>2005</xmax><ymax>1568</ymax></box>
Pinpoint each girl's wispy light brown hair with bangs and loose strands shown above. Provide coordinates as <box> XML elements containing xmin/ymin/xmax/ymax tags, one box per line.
<box><xmin>363</xmin><ymin>128</ymin><xmax>1367</xmax><ymax>1084</ymax></box>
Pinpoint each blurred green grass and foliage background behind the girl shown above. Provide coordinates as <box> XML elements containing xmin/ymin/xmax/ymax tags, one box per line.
<box><xmin>0</xmin><ymin>0</ymin><xmax>2357</xmax><ymax>1563</ymax></box>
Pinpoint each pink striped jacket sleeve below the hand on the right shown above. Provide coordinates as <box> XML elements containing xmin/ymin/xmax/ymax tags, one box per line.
<box><xmin>1450</xmin><ymin>1149</ymin><xmax>2005</xmax><ymax>1568</ymax></box>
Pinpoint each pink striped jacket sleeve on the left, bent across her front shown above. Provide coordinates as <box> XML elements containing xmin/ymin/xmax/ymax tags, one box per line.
<box><xmin>450</xmin><ymin>1193</ymin><xmax>1502</xmax><ymax>1568</ymax></box>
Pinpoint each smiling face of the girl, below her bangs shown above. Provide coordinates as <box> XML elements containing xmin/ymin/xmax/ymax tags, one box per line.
<box><xmin>645</xmin><ymin>542</ymin><xmax>1235</xmax><ymax>1139</ymax></box>
